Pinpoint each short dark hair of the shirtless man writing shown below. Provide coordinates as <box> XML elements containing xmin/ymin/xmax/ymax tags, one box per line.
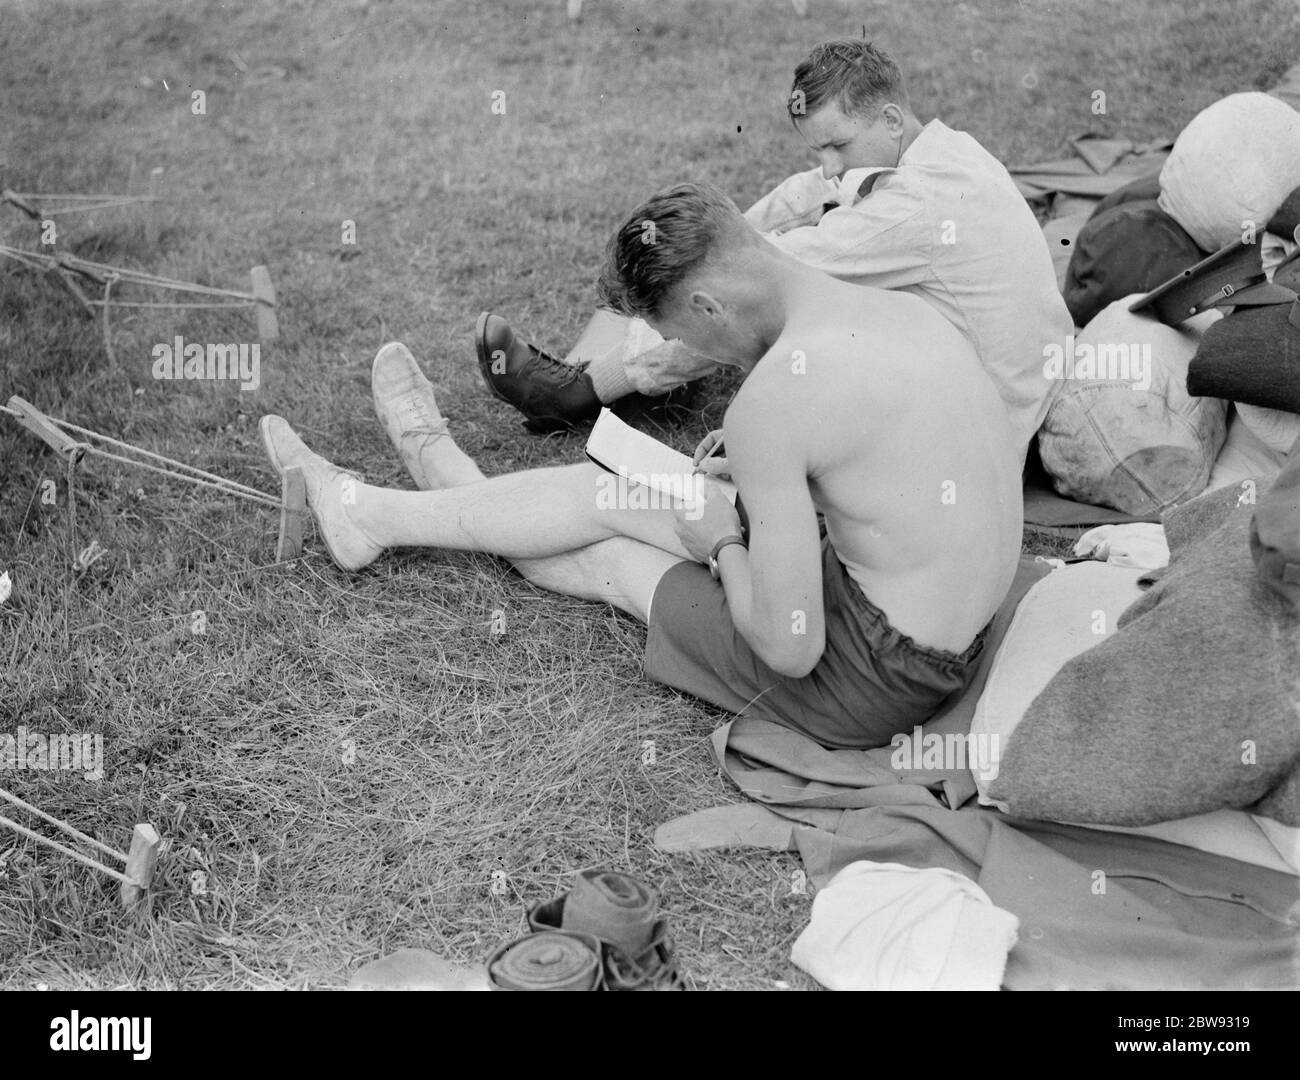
<box><xmin>597</xmin><ymin>183</ymin><xmax>757</xmax><ymax>318</ymax></box>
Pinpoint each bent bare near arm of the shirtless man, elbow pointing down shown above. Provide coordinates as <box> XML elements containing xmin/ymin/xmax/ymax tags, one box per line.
<box><xmin>718</xmin><ymin>399</ymin><xmax>826</xmax><ymax>678</ymax></box>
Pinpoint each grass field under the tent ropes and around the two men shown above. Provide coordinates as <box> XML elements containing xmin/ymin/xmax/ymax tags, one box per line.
<box><xmin>0</xmin><ymin>0</ymin><xmax>1300</xmax><ymax>989</ymax></box>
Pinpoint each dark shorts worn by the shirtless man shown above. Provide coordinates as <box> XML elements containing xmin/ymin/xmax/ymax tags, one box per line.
<box><xmin>645</xmin><ymin>539</ymin><xmax>988</xmax><ymax>749</ymax></box>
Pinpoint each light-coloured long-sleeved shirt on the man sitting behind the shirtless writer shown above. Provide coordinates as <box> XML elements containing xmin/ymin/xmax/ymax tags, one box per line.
<box><xmin>745</xmin><ymin>120</ymin><xmax>1074</xmax><ymax>447</ymax></box>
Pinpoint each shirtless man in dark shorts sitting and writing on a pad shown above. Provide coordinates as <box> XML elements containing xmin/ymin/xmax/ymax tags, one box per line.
<box><xmin>263</xmin><ymin>185</ymin><xmax>1022</xmax><ymax>747</ymax></box>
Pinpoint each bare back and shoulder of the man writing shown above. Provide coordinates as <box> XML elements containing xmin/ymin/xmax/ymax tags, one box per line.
<box><xmin>724</xmin><ymin>281</ymin><xmax>1023</xmax><ymax>652</ymax></box>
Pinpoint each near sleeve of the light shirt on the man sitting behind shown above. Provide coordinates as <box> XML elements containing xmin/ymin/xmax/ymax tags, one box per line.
<box><xmin>768</xmin><ymin>186</ymin><xmax>933</xmax><ymax>289</ymax></box>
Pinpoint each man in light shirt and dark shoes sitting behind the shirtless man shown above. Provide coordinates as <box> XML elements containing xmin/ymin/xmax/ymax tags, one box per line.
<box><xmin>477</xmin><ymin>40</ymin><xmax>1074</xmax><ymax>454</ymax></box>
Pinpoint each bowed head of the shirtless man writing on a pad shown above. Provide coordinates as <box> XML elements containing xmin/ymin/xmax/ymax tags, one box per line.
<box><xmin>597</xmin><ymin>183</ymin><xmax>768</xmax><ymax>366</ymax></box>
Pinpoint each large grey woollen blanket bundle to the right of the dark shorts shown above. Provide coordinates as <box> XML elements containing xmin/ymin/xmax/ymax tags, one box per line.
<box><xmin>988</xmin><ymin>480</ymin><xmax>1300</xmax><ymax>825</ymax></box>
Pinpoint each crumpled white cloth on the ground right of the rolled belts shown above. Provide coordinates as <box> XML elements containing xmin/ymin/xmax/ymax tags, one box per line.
<box><xmin>790</xmin><ymin>862</ymin><xmax>1019</xmax><ymax>990</ymax></box>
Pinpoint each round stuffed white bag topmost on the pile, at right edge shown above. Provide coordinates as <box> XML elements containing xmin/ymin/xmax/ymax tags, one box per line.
<box><xmin>1157</xmin><ymin>91</ymin><xmax>1300</xmax><ymax>251</ymax></box>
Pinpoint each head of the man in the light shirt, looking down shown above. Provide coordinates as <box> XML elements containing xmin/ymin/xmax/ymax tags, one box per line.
<box><xmin>787</xmin><ymin>39</ymin><xmax>915</xmax><ymax>179</ymax></box>
